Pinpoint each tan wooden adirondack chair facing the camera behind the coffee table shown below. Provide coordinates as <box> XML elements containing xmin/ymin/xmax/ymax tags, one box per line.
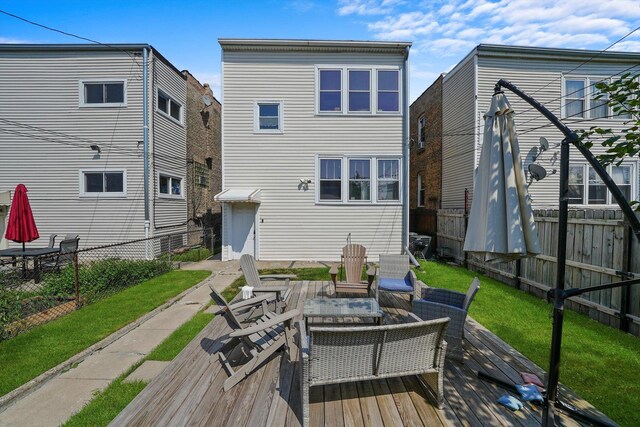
<box><xmin>329</xmin><ymin>243</ymin><xmax>375</xmax><ymax>294</ymax></box>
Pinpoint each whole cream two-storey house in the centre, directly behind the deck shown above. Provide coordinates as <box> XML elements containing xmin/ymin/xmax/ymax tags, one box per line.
<box><xmin>216</xmin><ymin>39</ymin><xmax>411</xmax><ymax>261</ymax></box>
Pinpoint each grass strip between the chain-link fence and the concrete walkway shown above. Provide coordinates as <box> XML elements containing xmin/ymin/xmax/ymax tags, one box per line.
<box><xmin>0</xmin><ymin>270</ymin><xmax>210</xmax><ymax>395</ymax></box>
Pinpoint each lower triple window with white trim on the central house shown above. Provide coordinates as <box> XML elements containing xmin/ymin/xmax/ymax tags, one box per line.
<box><xmin>316</xmin><ymin>156</ymin><xmax>402</xmax><ymax>204</ymax></box>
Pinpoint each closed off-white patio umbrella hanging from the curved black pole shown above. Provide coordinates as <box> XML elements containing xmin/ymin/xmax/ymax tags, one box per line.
<box><xmin>464</xmin><ymin>92</ymin><xmax>540</xmax><ymax>261</ymax></box>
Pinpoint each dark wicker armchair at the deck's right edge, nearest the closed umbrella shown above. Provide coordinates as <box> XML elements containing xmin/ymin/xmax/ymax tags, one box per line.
<box><xmin>411</xmin><ymin>277</ymin><xmax>480</xmax><ymax>362</ymax></box>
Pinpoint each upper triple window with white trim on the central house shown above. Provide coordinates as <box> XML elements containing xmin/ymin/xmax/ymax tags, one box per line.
<box><xmin>316</xmin><ymin>65</ymin><xmax>401</xmax><ymax>115</ymax></box>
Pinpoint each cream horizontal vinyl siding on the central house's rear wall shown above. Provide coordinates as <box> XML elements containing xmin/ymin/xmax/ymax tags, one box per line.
<box><xmin>222</xmin><ymin>50</ymin><xmax>403</xmax><ymax>260</ymax></box>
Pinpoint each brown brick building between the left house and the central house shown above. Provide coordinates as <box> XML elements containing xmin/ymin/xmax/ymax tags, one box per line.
<box><xmin>183</xmin><ymin>71</ymin><xmax>222</xmax><ymax>244</ymax></box>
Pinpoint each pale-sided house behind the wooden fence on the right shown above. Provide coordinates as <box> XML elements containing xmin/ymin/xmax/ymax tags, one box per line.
<box><xmin>442</xmin><ymin>44</ymin><xmax>640</xmax><ymax>208</ymax></box>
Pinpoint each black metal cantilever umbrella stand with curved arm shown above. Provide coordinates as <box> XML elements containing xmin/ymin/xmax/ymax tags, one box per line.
<box><xmin>495</xmin><ymin>79</ymin><xmax>640</xmax><ymax>427</ymax></box>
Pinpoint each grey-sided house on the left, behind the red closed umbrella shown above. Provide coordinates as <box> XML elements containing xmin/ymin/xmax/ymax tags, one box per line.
<box><xmin>0</xmin><ymin>44</ymin><xmax>187</xmax><ymax>247</ymax></box>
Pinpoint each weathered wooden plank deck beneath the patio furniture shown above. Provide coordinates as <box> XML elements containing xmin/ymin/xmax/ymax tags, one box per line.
<box><xmin>111</xmin><ymin>281</ymin><xmax>606</xmax><ymax>426</ymax></box>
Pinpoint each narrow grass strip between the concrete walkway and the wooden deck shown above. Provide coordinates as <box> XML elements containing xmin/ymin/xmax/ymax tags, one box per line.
<box><xmin>64</xmin><ymin>311</ymin><xmax>214</xmax><ymax>427</ymax></box>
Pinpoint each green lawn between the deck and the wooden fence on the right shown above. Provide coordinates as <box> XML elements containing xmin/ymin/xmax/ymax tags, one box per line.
<box><xmin>418</xmin><ymin>262</ymin><xmax>640</xmax><ymax>426</ymax></box>
